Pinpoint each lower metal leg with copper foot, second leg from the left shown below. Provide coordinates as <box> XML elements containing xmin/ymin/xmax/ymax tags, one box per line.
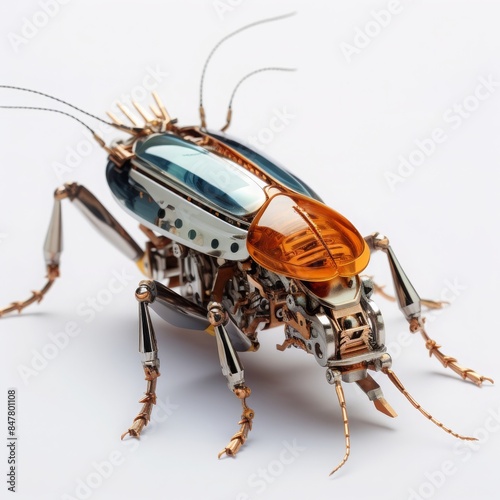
<box><xmin>121</xmin><ymin>281</ymin><xmax>160</xmax><ymax>439</ymax></box>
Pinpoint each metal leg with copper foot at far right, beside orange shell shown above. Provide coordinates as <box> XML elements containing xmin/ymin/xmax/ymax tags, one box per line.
<box><xmin>365</xmin><ymin>233</ymin><xmax>493</xmax><ymax>386</ymax></box>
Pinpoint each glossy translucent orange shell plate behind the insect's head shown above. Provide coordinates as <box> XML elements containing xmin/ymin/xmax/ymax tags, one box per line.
<box><xmin>247</xmin><ymin>193</ymin><xmax>370</xmax><ymax>281</ymax></box>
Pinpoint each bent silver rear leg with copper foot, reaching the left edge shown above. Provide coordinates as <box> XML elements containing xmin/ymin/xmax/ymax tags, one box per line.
<box><xmin>0</xmin><ymin>183</ymin><xmax>143</xmax><ymax>317</ymax></box>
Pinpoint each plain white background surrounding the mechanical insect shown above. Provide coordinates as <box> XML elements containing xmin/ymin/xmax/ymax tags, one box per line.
<box><xmin>0</xmin><ymin>0</ymin><xmax>500</xmax><ymax>499</ymax></box>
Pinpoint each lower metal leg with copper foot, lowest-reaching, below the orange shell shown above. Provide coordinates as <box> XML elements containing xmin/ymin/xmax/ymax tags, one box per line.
<box><xmin>208</xmin><ymin>302</ymin><xmax>255</xmax><ymax>458</ymax></box>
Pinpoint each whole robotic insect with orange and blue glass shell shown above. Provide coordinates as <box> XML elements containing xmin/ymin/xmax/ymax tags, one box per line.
<box><xmin>0</xmin><ymin>16</ymin><xmax>493</xmax><ymax>473</ymax></box>
